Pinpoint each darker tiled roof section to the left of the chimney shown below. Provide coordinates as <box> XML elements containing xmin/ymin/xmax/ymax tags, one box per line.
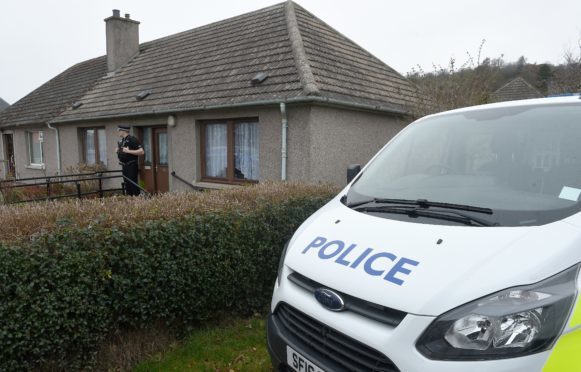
<box><xmin>0</xmin><ymin>56</ymin><xmax>107</xmax><ymax>126</ymax></box>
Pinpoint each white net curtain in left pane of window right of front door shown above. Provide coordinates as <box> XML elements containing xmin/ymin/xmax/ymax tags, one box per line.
<box><xmin>205</xmin><ymin>124</ymin><xmax>228</xmax><ymax>178</ymax></box>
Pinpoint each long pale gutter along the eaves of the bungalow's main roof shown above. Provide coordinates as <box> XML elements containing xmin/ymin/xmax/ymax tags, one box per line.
<box><xmin>48</xmin><ymin>96</ymin><xmax>410</xmax><ymax>124</ymax></box>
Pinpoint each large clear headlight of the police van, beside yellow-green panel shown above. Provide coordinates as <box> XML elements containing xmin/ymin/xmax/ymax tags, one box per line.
<box><xmin>417</xmin><ymin>265</ymin><xmax>579</xmax><ymax>360</ymax></box>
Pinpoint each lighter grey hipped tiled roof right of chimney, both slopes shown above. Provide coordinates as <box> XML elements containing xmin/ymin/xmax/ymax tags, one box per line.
<box><xmin>0</xmin><ymin>1</ymin><xmax>414</xmax><ymax>127</ymax></box>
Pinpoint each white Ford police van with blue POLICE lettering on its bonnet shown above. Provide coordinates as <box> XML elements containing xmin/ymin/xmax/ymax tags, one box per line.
<box><xmin>267</xmin><ymin>97</ymin><xmax>581</xmax><ymax>372</ymax></box>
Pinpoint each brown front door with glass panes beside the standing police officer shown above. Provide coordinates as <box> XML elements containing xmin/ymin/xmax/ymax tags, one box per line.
<box><xmin>140</xmin><ymin>127</ymin><xmax>169</xmax><ymax>193</ymax></box>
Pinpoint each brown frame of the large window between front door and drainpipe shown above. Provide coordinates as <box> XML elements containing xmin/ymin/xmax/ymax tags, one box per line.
<box><xmin>200</xmin><ymin>117</ymin><xmax>260</xmax><ymax>185</ymax></box>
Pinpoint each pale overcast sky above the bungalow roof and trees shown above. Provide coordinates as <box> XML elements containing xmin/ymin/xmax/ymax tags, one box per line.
<box><xmin>0</xmin><ymin>0</ymin><xmax>581</xmax><ymax>103</ymax></box>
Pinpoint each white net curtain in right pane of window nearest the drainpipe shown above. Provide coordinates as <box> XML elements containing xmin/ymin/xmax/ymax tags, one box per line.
<box><xmin>234</xmin><ymin>123</ymin><xmax>260</xmax><ymax>180</ymax></box>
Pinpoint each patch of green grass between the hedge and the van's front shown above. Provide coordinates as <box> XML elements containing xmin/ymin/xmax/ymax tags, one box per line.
<box><xmin>134</xmin><ymin>317</ymin><xmax>272</xmax><ymax>372</ymax></box>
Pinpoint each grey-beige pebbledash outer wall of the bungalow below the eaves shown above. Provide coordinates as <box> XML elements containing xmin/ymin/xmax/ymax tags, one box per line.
<box><xmin>4</xmin><ymin>104</ymin><xmax>409</xmax><ymax>187</ymax></box>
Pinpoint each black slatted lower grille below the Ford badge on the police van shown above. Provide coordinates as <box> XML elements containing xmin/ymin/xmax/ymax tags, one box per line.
<box><xmin>274</xmin><ymin>303</ymin><xmax>399</xmax><ymax>372</ymax></box>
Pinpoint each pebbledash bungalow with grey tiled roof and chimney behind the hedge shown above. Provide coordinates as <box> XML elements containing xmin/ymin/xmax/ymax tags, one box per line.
<box><xmin>0</xmin><ymin>1</ymin><xmax>416</xmax><ymax>192</ymax></box>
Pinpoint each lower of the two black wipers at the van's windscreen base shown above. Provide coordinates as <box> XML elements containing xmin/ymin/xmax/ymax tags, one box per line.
<box><xmin>355</xmin><ymin>205</ymin><xmax>498</xmax><ymax>226</ymax></box>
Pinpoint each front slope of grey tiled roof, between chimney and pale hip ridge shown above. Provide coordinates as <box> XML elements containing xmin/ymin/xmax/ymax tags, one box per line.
<box><xmin>59</xmin><ymin>5</ymin><xmax>301</xmax><ymax>120</ymax></box>
